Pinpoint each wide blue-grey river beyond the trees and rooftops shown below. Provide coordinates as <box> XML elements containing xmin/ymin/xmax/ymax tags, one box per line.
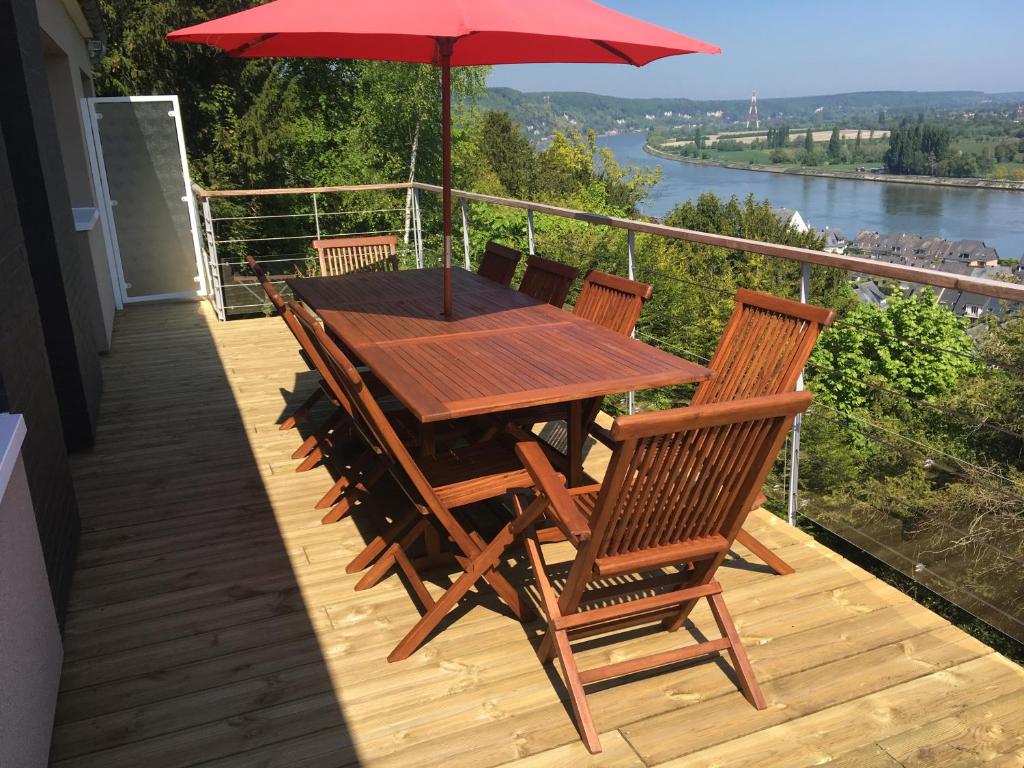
<box><xmin>598</xmin><ymin>133</ymin><xmax>1024</xmax><ymax>259</ymax></box>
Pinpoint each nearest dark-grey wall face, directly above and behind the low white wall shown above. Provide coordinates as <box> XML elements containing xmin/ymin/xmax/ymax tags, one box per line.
<box><xmin>0</xmin><ymin>121</ymin><xmax>79</xmax><ymax>623</ymax></box>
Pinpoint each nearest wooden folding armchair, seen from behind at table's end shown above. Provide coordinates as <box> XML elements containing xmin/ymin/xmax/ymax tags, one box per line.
<box><xmin>516</xmin><ymin>392</ymin><xmax>811</xmax><ymax>753</ymax></box>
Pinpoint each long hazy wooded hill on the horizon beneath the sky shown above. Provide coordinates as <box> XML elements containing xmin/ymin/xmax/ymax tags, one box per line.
<box><xmin>480</xmin><ymin>88</ymin><xmax>1024</xmax><ymax>136</ymax></box>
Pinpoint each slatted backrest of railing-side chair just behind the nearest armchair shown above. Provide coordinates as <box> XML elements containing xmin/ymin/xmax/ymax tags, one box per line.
<box><xmin>690</xmin><ymin>289</ymin><xmax>836</xmax><ymax>406</ymax></box>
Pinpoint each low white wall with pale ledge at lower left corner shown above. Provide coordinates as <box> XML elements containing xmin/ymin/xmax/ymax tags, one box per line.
<box><xmin>0</xmin><ymin>421</ymin><xmax>63</xmax><ymax>768</ymax></box>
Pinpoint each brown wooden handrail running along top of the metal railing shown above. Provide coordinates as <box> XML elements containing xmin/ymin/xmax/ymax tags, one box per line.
<box><xmin>193</xmin><ymin>181</ymin><xmax>1024</xmax><ymax>304</ymax></box>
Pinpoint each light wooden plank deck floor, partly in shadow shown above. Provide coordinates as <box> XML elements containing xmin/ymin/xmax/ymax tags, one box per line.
<box><xmin>52</xmin><ymin>304</ymin><xmax>1024</xmax><ymax>768</ymax></box>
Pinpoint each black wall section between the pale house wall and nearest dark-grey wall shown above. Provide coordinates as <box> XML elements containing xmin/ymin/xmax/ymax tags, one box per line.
<box><xmin>0</xmin><ymin>0</ymin><xmax>101</xmax><ymax>451</ymax></box>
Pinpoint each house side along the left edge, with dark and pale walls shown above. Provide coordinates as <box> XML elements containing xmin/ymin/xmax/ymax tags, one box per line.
<box><xmin>0</xmin><ymin>0</ymin><xmax>115</xmax><ymax>766</ymax></box>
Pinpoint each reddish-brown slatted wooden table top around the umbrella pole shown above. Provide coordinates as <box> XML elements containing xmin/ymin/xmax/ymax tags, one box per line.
<box><xmin>288</xmin><ymin>268</ymin><xmax>713</xmax><ymax>423</ymax></box>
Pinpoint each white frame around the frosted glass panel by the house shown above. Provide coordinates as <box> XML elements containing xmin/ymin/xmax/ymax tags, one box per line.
<box><xmin>83</xmin><ymin>95</ymin><xmax>210</xmax><ymax>309</ymax></box>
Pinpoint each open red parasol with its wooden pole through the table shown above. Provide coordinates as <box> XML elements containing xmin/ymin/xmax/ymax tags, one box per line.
<box><xmin>167</xmin><ymin>0</ymin><xmax>721</xmax><ymax>316</ymax></box>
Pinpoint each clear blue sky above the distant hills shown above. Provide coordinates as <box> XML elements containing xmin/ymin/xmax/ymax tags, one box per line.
<box><xmin>487</xmin><ymin>0</ymin><xmax>1024</xmax><ymax>99</ymax></box>
